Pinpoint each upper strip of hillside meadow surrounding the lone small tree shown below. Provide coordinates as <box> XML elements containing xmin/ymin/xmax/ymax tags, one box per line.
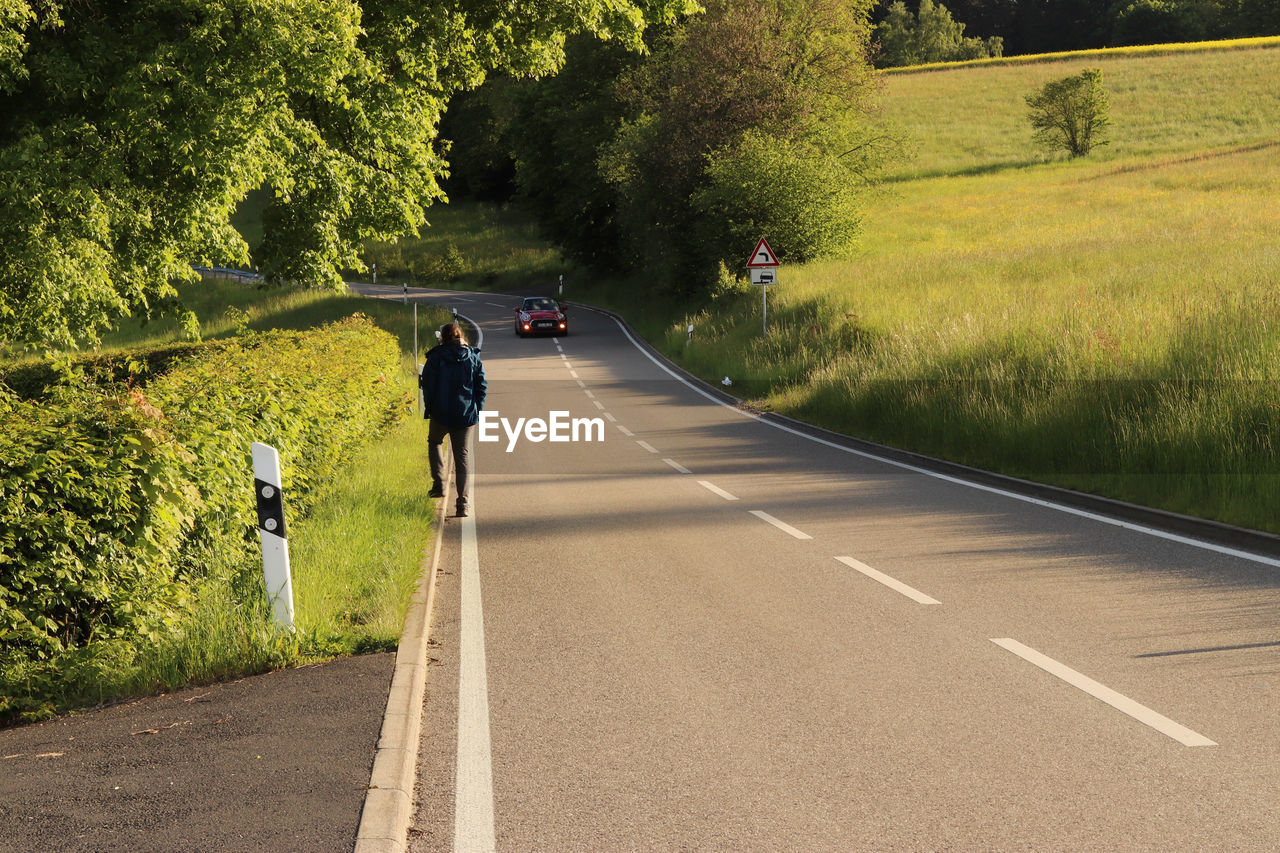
<box><xmin>882</xmin><ymin>40</ymin><xmax>1280</xmax><ymax>179</ymax></box>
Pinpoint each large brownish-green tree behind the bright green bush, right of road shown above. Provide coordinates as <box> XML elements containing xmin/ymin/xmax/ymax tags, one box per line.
<box><xmin>600</xmin><ymin>0</ymin><xmax>883</xmax><ymax>291</ymax></box>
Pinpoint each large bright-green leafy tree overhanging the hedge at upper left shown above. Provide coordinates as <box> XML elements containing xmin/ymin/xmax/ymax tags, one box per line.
<box><xmin>0</xmin><ymin>0</ymin><xmax>692</xmax><ymax>346</ymax></box>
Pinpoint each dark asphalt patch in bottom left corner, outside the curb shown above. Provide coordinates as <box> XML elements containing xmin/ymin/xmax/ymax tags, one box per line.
<box><xmin>0</xmin><ymin>653</ymin><xmax>396</xmax><ymax>853</ymax></box>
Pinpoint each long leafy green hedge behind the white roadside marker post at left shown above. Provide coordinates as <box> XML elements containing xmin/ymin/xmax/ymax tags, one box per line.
<box><xmin>0</xmin><ymin>315</ymin><xmax>412</xmax><ymax>720</ymax></box>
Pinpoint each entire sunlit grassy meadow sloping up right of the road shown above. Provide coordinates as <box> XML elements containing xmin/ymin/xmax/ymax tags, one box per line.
<box><xmin>576</xmin><ymin>46</ymin><xmax>1280</xmax><ymax>532</ymax></box>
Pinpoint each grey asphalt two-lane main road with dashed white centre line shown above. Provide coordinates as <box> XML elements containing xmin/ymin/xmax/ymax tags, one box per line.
<box><xmin>371</xmin><ymin>286</ymin><xmax>1280</xmax><ymax>852</ymax></box>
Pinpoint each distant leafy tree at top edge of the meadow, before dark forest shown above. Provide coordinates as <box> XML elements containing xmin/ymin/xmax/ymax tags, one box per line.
<box><xmin>876</xmin><ymin>0</ymin><xmax>1004</xmax><ymax>68</ymax></box>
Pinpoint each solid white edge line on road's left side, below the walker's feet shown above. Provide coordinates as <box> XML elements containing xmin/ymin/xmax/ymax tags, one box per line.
<box><xmin>453</xmin><ymin>503</ymin><xmax>497</xmax><ymax>853</ymax></box>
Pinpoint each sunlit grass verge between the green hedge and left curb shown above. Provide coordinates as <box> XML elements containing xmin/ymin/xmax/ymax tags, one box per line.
<box><xmin>14</xmin><ymin>419</ymin><xmax>434</xmax><ymax>722</ymax></box>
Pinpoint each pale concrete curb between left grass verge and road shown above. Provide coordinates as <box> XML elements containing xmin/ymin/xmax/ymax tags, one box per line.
<box><xmin>356</xmin><ymin>453</ymin><xmax>453</xmax><ymax>853</ymax></box>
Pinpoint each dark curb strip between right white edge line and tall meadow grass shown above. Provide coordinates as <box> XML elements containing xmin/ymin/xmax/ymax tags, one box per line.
<box><xmin>576</xmin><ymin>300</ymin><xmax>1280</xmax><ymax>560</ymax></box>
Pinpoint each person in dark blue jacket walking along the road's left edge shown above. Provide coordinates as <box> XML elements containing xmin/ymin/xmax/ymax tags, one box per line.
<box><xmin>417</xmin><ymin>323</ymin><xmax>488</xmax><ymax>517</ymax></box>
